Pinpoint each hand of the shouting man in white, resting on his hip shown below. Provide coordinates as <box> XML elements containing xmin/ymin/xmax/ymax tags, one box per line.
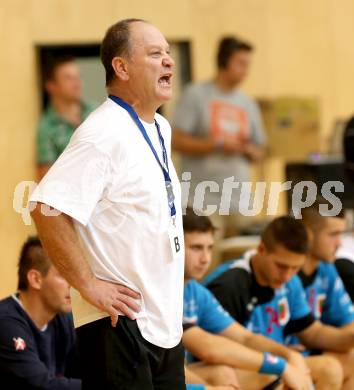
<box><xmin>80</xmin><ymin>278</ymin><xmax>140</xmax><ymax>326</ymax></box>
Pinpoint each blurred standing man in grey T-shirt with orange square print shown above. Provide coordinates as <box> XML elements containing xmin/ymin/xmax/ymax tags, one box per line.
<box><xmin>172</xmin><ymin>37</ymin><xmax>265</xmax><ymax>238</ymax></box>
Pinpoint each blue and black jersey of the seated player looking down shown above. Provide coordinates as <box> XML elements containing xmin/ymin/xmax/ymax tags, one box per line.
<box><xmin>207</xmin><ymin>252</ymin><xmax>314</xmax><ymax>343</ymax></box>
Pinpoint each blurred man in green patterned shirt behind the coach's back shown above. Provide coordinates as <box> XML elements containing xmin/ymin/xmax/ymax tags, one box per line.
<box><xmin>37</xmin><ymin>56</ymin><xmax>94</xmax><ymax>180</ymax></box>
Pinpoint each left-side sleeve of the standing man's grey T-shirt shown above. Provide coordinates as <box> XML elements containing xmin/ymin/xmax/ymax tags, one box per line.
<box><xmin>171</xmin><ymin>85</ymin><xmax>200</xmax><ymax>134</ymax></box>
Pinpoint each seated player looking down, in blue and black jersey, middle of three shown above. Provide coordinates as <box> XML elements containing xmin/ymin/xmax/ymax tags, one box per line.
<box><xmin>207</xmin><ymin>217</ymin><xmax>348</xmax><ymax>389</ymax></box>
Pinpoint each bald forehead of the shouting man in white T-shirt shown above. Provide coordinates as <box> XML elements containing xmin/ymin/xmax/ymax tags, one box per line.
<box><xmin>130</xmin><ymin>22</ymin><xmax>168</xmax><ymax>51</ymax></box>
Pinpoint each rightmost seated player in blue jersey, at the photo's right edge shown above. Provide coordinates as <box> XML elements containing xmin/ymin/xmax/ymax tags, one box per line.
<box><xmin>298</xmin><ymin>198</ymin><xmax>354</xmax><ymax>390</ymax></box>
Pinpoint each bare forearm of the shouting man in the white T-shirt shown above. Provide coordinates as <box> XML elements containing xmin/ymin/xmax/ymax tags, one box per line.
<box><xmin>31</xmin><ymin>203</ymin><xmax>94</xmax><ymax>290</ymax></box>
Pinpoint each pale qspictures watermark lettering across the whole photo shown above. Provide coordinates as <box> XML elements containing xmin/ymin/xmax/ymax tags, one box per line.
<box><xmin>13</xmin><ymin>172</ymin><xmax>344</xmax><ymax>227</ymax></box>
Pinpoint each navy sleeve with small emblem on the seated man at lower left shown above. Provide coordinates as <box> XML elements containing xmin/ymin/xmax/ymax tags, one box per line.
<box><xmin>0</xmin><ymin>319</ymin><xmax>81</xmax><ymax>390</ymax></box>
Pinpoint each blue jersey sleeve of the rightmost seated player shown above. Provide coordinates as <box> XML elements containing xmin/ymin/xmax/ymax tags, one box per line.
<box><xmin>321</xmin><ymin>264</ymin><xmax>354</xmax><ymax>326</ymax></box>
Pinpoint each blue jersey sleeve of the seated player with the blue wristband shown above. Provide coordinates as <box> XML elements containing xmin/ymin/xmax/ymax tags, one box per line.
<box><xmin>198</xmin><ymin>285</ymin><xmax>235</xmax><ymax>333</ymax></box>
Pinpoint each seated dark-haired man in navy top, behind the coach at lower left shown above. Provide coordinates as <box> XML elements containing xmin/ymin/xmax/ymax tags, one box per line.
<box><xmin>0</xmin><ymin>237</ymin><xmax>81</xmax><ymax>390</ymax></box>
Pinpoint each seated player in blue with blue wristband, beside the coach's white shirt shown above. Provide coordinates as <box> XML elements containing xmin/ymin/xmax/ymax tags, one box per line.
<box><xmin>182</xmin><ymin>208</ymin><xmax>312</xmax><ymax>390</ymax></box>
